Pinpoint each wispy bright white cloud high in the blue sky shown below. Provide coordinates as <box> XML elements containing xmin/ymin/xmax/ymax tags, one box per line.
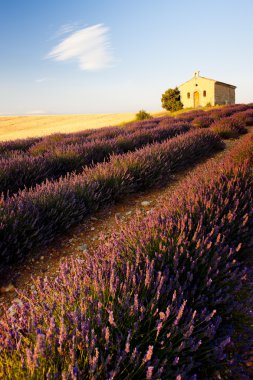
<box><xmin>48</xmin><ymin>24</ymin><xmax>113</xmax><ymax>71</ymax></box>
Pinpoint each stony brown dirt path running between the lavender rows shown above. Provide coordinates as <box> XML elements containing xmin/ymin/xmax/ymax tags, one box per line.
<box><xmin>0</xmin><ymin>141</ymin><xmax>241</xmax><ymax>307</ymax></box>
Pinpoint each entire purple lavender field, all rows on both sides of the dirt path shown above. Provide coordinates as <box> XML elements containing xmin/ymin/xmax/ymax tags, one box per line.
<box><xmin>0</xmin><ymin>104</ymin><xmax>253</xmax><ymax>380</ymax></box>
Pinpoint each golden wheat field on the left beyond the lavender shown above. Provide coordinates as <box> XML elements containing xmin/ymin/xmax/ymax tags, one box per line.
<box><xmin>0</xmin><ymin>113</ymin><xmax>140</xmax><ymax>141</ymax></box>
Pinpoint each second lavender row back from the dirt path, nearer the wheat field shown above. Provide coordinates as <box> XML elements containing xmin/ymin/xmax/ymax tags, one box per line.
<box><xmin>0</xmin><ymin>123</ymin><xmax>190</xmax><ymax>196</ymax></box>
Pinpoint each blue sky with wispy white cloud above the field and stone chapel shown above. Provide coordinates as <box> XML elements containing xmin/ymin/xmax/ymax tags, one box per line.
<box><xmin>0</xmin><ymin>0</ymin><xmax>253</xmax><ymax>115</ymax></box>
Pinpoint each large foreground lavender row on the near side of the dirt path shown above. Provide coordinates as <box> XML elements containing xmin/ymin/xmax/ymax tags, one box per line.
<box><xmin>0</xmin><ymin>137</ymin><xmax>253</xmax><ymax>380</ymax></box>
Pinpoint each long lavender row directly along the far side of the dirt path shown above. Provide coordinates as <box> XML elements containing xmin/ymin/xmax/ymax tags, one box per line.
<box><xmin>0</xmin><ymin>130</ymin><xmax>223</xmax><ymax>272</ymax></box>
